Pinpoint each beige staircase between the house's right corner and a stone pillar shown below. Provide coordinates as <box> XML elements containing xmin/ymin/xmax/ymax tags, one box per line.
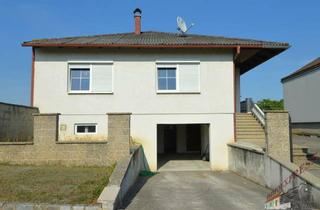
<box><xmin>236</xmin><ymin>113</ymin><xmax>265</xmax><ymax>148</ymax></box>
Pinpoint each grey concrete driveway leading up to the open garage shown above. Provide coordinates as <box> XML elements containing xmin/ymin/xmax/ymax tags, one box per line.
<box><xmin>126</xmin><ymin>171</ymin><xmax>270</xmax><ymax>210</ymax></box>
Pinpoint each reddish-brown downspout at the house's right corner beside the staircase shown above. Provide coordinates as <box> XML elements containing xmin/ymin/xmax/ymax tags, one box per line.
<box><xmin>233</xmin><ymin>45</ymin><xmax>240</xmax><ymax>142</ymax></box>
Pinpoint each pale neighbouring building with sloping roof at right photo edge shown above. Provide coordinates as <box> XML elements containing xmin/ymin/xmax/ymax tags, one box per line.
<box><xmin>281</xmin><ymin>58</ymin><xmax>320</xmax><ymax>133</ymax></box>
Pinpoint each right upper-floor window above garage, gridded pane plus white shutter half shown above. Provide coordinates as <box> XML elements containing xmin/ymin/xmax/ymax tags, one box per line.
<box><xmin>157</xmin><ymin>62</ymin><xmax>200</xmax><ymax>93</ymax></box>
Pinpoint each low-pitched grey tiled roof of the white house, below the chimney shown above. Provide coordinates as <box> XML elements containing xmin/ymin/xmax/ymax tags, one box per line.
<box><xmin>23</xmin><ymin>31</ymin><xmax>289</xmax><ymax>48</ymax></box>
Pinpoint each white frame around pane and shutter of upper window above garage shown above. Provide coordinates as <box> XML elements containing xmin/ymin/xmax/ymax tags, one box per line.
<box><xmin>156</xmin><ymin>61</ymin><xmax>201</xmax><ymax>94</ymax></box>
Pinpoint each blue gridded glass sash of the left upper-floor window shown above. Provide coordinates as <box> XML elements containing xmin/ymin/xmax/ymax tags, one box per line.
<box><xmin>70</xmin><ymin>68</ymin><xmax>90</xmax><ymax>91</ymax></box>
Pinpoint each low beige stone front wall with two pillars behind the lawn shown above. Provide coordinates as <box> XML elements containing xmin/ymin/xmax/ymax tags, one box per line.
<box><xmin>0</xmin><ymin>114</ymin><xmax>130</xmax><ymax>166</ymax></box>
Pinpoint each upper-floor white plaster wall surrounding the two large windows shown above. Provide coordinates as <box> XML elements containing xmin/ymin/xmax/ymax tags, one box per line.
<box><xmin>34</xmin><ymin>49</ymin><xmax>234</xmax><ymax>114</ymax></box>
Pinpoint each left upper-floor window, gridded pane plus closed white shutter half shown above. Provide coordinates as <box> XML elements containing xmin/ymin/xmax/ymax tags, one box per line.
<box><xmin>68</xmin><ymin>62</ymin><xmax>113</xmax><ymax>94</ymax></box>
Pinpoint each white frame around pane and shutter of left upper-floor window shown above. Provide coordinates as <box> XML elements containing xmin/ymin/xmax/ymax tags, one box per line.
<box><xmin>67</xmin><ymin>61</ymin><xmax>114</xmax><ymax>94</ymax></box>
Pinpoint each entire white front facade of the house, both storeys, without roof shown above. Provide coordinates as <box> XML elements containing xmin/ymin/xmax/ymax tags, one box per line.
<box><xmin>34</xmin><ymin>48</ymin><xmax>239</xmax><ymax>170</ymax></box>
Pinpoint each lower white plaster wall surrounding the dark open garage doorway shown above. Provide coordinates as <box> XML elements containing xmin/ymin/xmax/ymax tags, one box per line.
<box><xmin>131</xmin><ymin>114</ymin><xmax>233</xmax><ymax>171</ymax></box>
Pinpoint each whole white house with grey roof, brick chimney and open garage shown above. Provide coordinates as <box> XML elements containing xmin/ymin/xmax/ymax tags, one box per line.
<box><xmin>23</xmin><ymin>10</ymin><xmax>289</xmax><ymax>170</ymax></box>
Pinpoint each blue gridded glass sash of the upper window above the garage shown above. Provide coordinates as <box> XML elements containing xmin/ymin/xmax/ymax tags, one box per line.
<box><xmin>158</xmin><ymin>67</ymin><xmax>177</xmax><ymax>90</ymax></box>
